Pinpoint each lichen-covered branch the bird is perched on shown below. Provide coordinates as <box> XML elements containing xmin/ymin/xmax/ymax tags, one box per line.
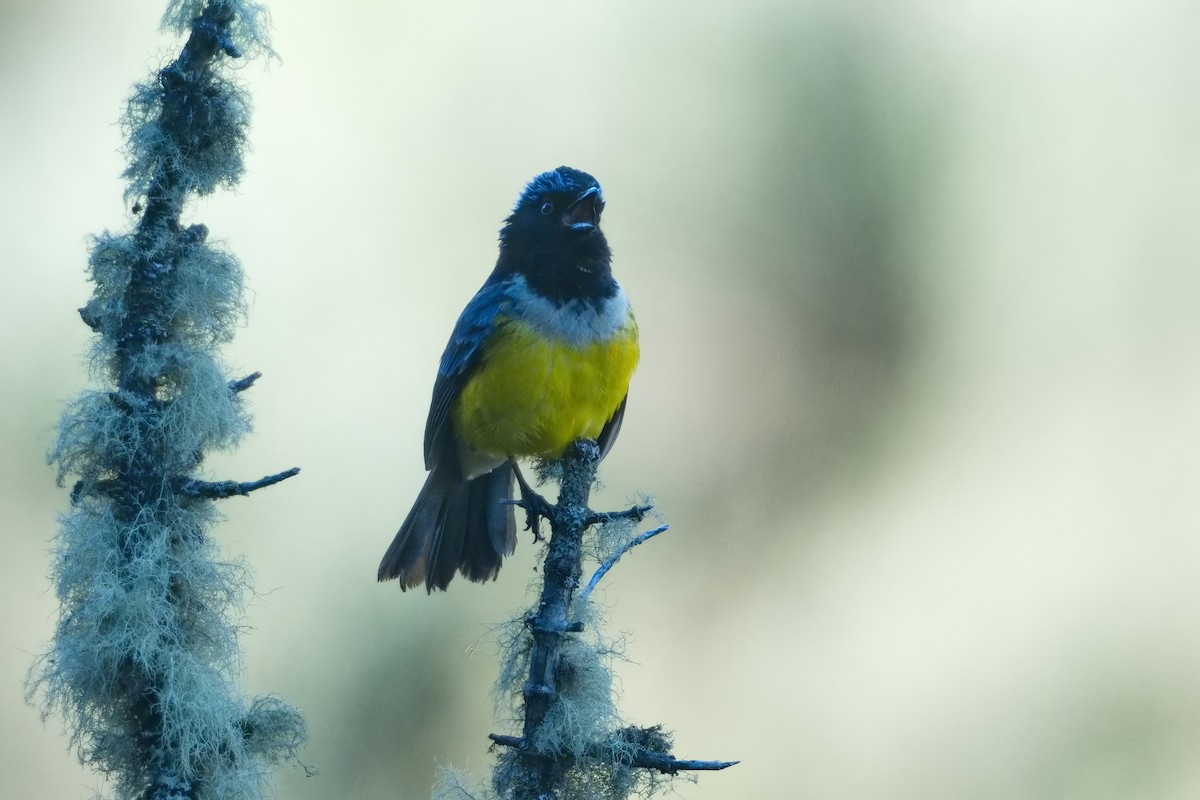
<box><xmin>468</xmin><ymin>440</ymin><xmax>737</xmax><ymax>800</ymax></box>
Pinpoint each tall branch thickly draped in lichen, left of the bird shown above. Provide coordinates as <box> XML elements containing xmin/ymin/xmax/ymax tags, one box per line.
<box><xmin>30</xmin><ymin>0</ymin><xmax>305</xmax><ymax>800</ymax></box>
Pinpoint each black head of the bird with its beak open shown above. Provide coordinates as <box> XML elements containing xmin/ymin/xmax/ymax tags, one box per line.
<box><xmin>496</xmin><ymin>167</ymin><xmax>617</xmax><ymax>301</ymax></box>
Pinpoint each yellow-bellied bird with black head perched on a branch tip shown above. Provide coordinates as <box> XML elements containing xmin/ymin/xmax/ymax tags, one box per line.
<box><xmin>378</xmin><ymin>167</ymin><xmax>640</xmax><ymax>594</ymax></box>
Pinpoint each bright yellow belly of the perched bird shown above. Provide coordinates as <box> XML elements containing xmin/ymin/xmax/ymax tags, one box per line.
<box><xmin>450</xmin><ymin>312</ymin><xmax>638</xmax><ymax>457</ymax></box>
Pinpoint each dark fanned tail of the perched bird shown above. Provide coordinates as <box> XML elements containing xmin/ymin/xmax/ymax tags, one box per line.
<box><xmin>378</xmin><ymin>462</ymin><xmax>516</xmax><ymax>591</ymax></box>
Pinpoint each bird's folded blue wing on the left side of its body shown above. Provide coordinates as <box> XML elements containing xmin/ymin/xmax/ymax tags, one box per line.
<box><xmin>425</xmin><ymin>278</ymin><xmax>511</xmax><ymax>469</ymax></box>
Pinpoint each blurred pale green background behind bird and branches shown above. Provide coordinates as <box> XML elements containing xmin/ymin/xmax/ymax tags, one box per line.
<box><xmin>0</xmin><ymin>0</ymin><xmax>1200</xmax><ymax>800</ymax></box>
